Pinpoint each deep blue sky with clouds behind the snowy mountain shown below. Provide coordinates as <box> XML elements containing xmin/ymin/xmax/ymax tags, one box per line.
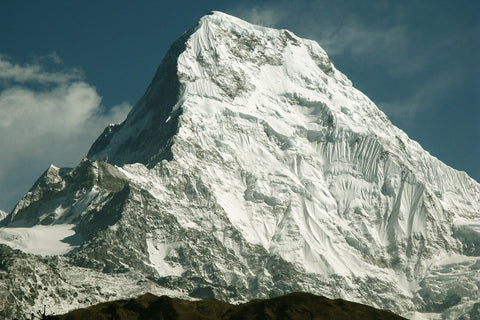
<box><xmin>0</xmin><ymin>0</ymin><xmax>480</xmax><ymax>211</ymax></box>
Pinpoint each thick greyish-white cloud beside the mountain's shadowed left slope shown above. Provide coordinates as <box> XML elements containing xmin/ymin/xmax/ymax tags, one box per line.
<box><xmin>0</xmin><ymin>57</ymin><xmax>131</xmax><ymax>210</ymax></box>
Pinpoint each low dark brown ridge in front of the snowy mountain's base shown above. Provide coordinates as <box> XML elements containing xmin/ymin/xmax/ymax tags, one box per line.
<box><xmin>53</xmin><ymin>293</ymin><xmax>405</xmax><ymax>320</ymax></box>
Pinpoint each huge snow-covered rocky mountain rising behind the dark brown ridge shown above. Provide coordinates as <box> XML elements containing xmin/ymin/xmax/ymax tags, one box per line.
<box><xmin>0</xmin><ymin>12</ymin><xmax>480</xmax><ymax>319</ymax></box>
